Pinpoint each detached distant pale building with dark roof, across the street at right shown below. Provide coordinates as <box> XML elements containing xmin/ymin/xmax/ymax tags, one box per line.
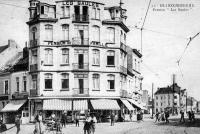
<box><xmin>154</xmin><ymin>83</ymin><xmax>181</xmax><ymax>114</ymax></box>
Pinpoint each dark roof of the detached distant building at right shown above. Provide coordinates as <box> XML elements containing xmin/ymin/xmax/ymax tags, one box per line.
<box><xmin>155</xmin><ymin>83</ymin><xmax>180</xmax><ymax>95</ymax></box>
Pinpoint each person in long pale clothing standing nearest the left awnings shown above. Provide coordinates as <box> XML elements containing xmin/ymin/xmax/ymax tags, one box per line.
<box><xmin>34</xmin><ymin>111</ymin><xmax>44</xmax><ymax>134</ymax></box>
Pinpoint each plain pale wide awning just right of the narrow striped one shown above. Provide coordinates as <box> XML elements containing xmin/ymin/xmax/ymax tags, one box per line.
<box><xmin>90</xmin><ymin>99</ymin><xmax>120</xmax><ymax>110</ymax></box>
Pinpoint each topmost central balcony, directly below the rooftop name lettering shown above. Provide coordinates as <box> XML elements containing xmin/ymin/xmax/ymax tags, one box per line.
<box><xmin>72</xmin><ymin>14</ymin><xmax>89</xmax><ymax>23</ymax></box>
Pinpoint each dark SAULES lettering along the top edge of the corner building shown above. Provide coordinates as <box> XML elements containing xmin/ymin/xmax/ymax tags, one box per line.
<box><xmin>63</xmin><ymin>1</ymin><xmax>99</xmax><ymax>8</ymax></box>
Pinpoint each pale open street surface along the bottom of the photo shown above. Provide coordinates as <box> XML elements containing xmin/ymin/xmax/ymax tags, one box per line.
<box><xmin>6</xmin><ymin>114</ymin><xmax>200</xmax><ymax>134</ymax></box>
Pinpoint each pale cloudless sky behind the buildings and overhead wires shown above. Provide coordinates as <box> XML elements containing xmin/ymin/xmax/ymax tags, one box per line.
<box><xmin>0</xmin><ymin>0</ymin><xmax>200</xmax><ymax>100</ymax></box>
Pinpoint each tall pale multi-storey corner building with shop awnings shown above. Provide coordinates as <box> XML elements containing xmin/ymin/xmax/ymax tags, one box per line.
<box><xmin>27</xmin><ymin>0</ymin><xmax>141</xmax><ymax>120</ymax></box>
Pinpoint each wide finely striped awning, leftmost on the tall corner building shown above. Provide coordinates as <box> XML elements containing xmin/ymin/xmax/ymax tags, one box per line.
<box><xmin>43</xmin><ymin>99</ymin><xmax>72</xmax><ymax>111</ymax></box>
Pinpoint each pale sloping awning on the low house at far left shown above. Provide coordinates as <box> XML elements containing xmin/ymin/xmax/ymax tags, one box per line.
<box><xmin>1</xmin><ymin>100</ymin><xmax>26</xmax><ymax>112</ymax></box>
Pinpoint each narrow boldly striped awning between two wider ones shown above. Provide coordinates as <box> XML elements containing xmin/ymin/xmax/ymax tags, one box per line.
<box><xmin>73</xmin><ymin>100</ymin><xmax>88</xmax><ymax>111</ymax></box>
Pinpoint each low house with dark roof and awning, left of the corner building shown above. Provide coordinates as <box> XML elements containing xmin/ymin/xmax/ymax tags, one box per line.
<box><xmin>0</xmin><ymin>48</ymin><xmax>29</xmax><ymax>124</ymax></box>
